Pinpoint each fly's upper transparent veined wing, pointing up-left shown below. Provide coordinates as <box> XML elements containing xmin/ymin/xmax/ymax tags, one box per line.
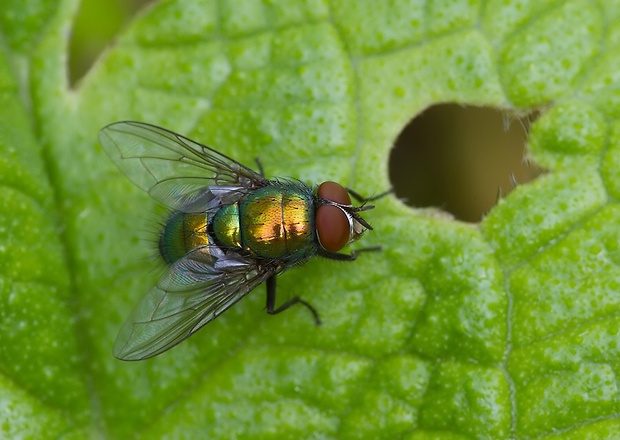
<box><xmin>99</xmin><ymin>121</ymin><xmax>268</xmax><ymax>210</ymax></box>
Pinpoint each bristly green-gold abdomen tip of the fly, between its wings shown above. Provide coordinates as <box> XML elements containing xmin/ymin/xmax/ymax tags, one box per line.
<box><xmin>159</xmin><ymin>211</ymin><xmax>209</xmax><ymax>264</ymax></box>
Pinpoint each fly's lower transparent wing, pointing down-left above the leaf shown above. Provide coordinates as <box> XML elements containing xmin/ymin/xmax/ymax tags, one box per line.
<box><xmin>114</xmin><ymin>246</ymin><xmax>276</xmax><ymax>361</ymax></box>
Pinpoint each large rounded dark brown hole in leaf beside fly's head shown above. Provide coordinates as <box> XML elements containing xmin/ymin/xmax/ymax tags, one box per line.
<box><xmin>390</xmin><ymin>104</ymin><xmax>543</xmax><ymax>222</ymax></box>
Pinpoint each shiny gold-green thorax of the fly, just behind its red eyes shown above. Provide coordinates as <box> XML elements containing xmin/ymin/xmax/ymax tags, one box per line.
<box><xmin>213</xmin><ymin>182</ymin><xmax>316</xmax><ymax>260</ymax></box>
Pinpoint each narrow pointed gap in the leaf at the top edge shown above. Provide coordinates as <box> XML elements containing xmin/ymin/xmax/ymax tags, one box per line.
<box><xmin>69</xmin><ymin>0</ymin><xmax>153</xmax><ymax>87</ymax></box>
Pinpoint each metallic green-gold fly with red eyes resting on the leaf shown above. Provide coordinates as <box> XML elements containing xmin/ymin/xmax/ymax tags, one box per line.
<box><xmin>99</xmin><ymin>121</ymin><xmax>389</xmax><ymax>360</ymax></box>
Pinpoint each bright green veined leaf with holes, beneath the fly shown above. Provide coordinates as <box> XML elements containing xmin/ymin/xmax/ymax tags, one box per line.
<box><xmin>0</xmin><ymin>0</ymin><xmax>620</xmax><ymax>439</ymax></box>
